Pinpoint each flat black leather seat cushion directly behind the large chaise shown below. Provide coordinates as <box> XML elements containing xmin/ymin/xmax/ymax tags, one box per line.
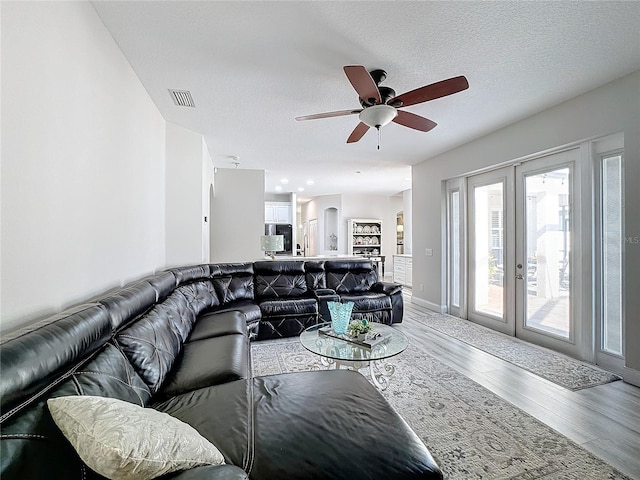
<box><xmin>161</xmin><ymin>334</ymin><xmax>249</xmax><ymax>397</ymax></box>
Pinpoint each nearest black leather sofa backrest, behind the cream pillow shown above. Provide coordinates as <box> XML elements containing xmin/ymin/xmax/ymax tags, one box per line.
<box><xmin>0</xmin><ymin>303</ymin><xmax>151</xmax><ymax>479</ymax></box>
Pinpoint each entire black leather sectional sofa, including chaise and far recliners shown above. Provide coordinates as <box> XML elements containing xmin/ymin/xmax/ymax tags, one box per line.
<box><xmin>0</xmin><ymin>261</ymin><xmax>442</xmax><ymax>480</ymax></box>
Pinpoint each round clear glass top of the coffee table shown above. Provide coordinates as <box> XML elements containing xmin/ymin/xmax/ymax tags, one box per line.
<box><xmin>300</xmin><ymin>322</ymin><xmax>409</xmax><ymax>361</ymax></box>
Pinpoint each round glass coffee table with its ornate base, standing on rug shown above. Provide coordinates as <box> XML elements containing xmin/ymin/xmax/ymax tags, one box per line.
<box><xmin>300</xmin><ymin>322</ymin><xmax>409</xmax><ymax>390</ymax></box>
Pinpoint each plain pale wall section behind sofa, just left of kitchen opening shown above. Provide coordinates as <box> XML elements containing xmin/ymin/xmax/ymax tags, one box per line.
<box><xmin>211</xmin><ymin>168</ymin><xmax>264</xmax><ymax>262</ymax></box>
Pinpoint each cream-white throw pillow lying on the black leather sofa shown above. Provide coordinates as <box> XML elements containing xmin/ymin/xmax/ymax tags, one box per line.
<box><xmin>47</xmin><ymin>396</ymin><xmax>224</xmax><ymax>480</ymax></box>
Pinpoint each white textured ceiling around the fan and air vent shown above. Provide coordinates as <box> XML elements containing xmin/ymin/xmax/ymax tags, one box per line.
<box><xmin>93</xmin><ymin>1</ymin><xmax>640</xmax><ymax>202</ymax></box>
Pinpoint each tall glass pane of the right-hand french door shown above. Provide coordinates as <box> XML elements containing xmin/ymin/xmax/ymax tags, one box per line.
<box><xmin>523</xmin><ymin>167</ymin><xmax>571</xmax><ymax>338</ymax></box>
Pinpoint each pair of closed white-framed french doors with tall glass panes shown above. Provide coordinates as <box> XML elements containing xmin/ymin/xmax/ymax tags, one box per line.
<box><xmin>466</xmin><ymin>148</ymin><xmax>585</xmax><ymax>357</ymax></box>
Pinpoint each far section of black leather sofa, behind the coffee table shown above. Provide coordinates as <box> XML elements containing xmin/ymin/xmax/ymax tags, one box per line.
<box><xmin>190</xmin><ymin>260</ymin><xmax>403</xmax><ymax>340</ymax></box>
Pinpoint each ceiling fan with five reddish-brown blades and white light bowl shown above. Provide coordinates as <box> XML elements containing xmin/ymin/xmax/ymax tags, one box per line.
<box><xmin>296</xmin><ymin>65</ymin><xmax>469</xmax><ymax>149</ymax></box>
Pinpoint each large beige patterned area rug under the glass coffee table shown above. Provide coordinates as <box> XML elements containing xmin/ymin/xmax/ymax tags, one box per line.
<box><xmin>251</xmin><ymin>340</ymin><xmax>629</xmax><ymax>480</ymax></box>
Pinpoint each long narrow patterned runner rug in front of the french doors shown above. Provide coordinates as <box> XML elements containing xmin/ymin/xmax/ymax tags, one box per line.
<box><xmin>405</xmin><ymin>310</ymin><xmax>622</xmax><ymax>392</ymax></box>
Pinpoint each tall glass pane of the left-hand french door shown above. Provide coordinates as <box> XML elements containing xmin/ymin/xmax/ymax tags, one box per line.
<box><xmin>472</xmin><ymin>182</ymin><xmax>505</xmax><ymax>318</ymax></box>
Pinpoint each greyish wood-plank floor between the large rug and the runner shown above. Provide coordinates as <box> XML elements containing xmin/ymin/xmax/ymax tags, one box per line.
<box><xmin>397</xmin><ymin>296</ymin><xmax>640</xmax><ymax>480</ymax></box>
